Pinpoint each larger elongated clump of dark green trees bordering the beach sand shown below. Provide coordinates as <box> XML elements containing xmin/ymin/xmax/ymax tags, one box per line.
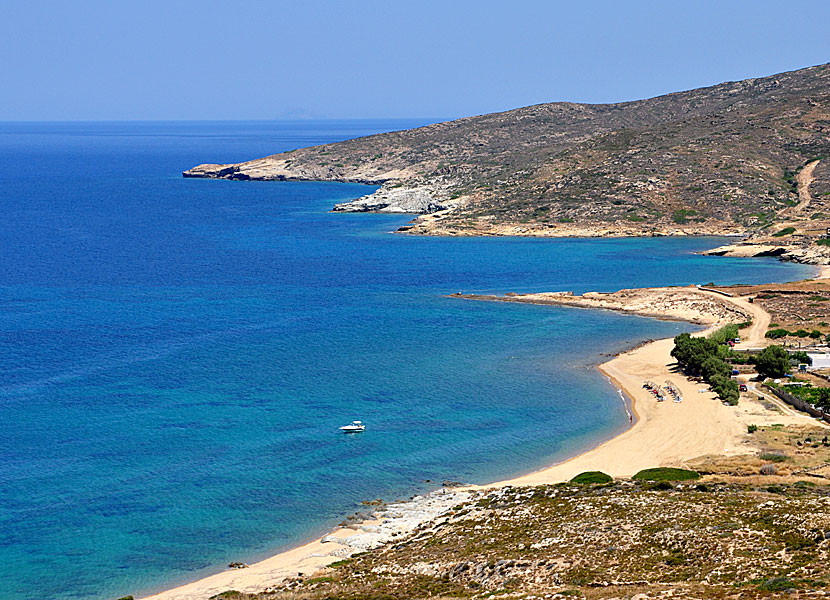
<box><xmin>671</xmin><ymin>327</ymin><xmax>740</xmax><ymax>404</ymax></box>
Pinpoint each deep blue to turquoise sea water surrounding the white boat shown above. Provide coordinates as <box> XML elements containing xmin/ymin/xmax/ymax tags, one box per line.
<box><xmin>0</xmin><ymin>121</ymin><xmax>811</xmax><ymax>600</ymax></box>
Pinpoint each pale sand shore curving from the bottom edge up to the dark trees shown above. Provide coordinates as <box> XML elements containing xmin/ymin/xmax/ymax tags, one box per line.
<box><xmin>142</xmin><ymin>268</ymin><xmax>830</xmax><ymax>600</ymax></box>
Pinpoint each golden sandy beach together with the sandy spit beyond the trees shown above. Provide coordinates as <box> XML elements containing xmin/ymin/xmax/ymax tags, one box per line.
<box><xmin>145</xmin><ymin>268</ymin><xmax>830</xmax><ymax>600</ymax></box>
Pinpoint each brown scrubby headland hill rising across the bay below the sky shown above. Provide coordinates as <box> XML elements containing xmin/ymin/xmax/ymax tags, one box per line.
<box><xmin>184</xmin><ymin>65</ymin><xmax>830</xmax><ymax>235</ymax></box>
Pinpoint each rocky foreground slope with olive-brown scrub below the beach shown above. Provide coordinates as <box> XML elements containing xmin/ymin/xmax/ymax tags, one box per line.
<box><xmin>214</xmin><ymin>481</ymin><xmax>830</xmax><ymax>600</ymax></box>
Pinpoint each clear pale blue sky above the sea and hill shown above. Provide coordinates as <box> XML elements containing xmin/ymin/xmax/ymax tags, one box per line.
<box><xmin>0</xmin><ymin>0</ymin><xmax>830</xmax><ymax>120</ymax></box>
